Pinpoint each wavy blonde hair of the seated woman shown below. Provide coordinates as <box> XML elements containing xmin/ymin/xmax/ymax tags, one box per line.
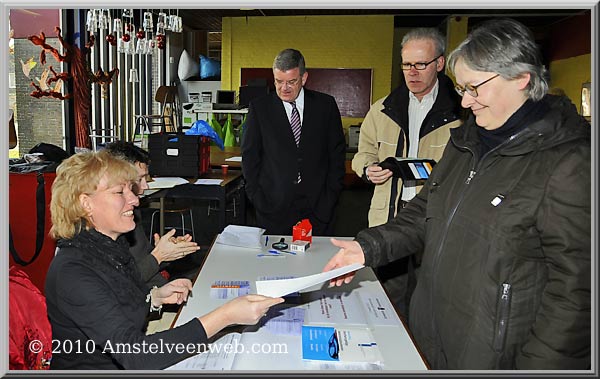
<box><xmin>50</xmin><ymin>150</ymin><xmax>138</xmax><ymax>239</ymax></box>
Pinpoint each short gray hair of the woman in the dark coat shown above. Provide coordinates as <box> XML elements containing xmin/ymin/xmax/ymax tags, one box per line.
<box><xmin>448</xmin><ymin>19</ymin><xmax>548</xmax><ymax>101</ymax></box>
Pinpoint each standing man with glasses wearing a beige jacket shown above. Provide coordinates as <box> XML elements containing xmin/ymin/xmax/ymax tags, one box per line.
<box><xmin>352</xmin><ymin>28</ymin><xmax>460</xmax><ymax>315</ymax></box>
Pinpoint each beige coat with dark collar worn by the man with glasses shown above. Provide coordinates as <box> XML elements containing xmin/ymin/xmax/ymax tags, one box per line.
<box><xmin>352</xmin><ymin>74</ymin><xmax>461</xmax><ymax>226</ymax></box>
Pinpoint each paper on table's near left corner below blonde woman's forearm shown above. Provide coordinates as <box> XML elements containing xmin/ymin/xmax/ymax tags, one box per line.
<box><xmin>165</xmin><ymin>333</ymin><xmax>241</xmax><ymax>370</ymax></box>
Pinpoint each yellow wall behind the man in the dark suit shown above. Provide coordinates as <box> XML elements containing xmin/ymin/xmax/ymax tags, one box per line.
<box><xmin>221</xmin><ymin>15</ymin><xmax>394</xmax><ymax>127</ymax></box>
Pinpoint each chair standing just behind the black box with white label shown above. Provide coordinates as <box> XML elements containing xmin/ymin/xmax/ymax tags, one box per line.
<box><xmin>131</xmin><ymin>86</ymin><xmax>181</xmax><ymax>143</ymax></box>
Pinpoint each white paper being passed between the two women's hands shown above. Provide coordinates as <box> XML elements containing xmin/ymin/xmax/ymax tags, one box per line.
<box><xmin>256</xmin><ymin>263</ymin><xmax>365</xmax><ymax>297</ymax></box>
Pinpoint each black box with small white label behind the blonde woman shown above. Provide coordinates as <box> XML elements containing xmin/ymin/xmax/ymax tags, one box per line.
<box><xmin>148</xmin><ymin>133</ymin><xmax>210</xmax><ymax>178</ymax></box>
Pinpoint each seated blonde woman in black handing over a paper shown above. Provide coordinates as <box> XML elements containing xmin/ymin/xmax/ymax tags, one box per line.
<box><xmin>46</xmin><ymin>151</ymin><xmax>283</xmax><ymax>370</ymax></box>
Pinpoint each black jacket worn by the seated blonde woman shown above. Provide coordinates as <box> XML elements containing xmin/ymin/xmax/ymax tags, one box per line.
<box><xmin>46</xmin><ymin>230</ymin><xmax>207</xmax><ymax>370</ymax></box>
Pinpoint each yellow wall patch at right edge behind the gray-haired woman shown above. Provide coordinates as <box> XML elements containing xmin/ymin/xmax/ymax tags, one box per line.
<box><xmin>550</xmin><ymin>54</ymin><xmax>592</xmax><ymax>111</ymax></box>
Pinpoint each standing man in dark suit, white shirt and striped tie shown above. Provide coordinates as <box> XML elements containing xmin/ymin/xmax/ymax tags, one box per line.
<box><xmin>242</xmin><ymin>49</ymin><xmax>345</xmax><ymax>235</ymax></box>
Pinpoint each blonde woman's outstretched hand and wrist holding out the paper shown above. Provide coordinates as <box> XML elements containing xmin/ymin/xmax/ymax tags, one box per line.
<box><xmin>199</xmin><ymin>295</ymin><xmax>284</xmax><ymax>338</ymax></box>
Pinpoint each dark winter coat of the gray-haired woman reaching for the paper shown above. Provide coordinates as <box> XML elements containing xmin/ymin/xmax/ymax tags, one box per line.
<box><xmin>356</xmin><ymin>96</ymin><xmax>591</xmax><ymax>370</ymax></box>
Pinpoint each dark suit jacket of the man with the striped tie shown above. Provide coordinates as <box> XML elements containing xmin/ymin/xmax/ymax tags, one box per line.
<box><xmin>242</xmin><ymin>89</ymin><xmax>346</xmax><ymax>223</ymax></box>
